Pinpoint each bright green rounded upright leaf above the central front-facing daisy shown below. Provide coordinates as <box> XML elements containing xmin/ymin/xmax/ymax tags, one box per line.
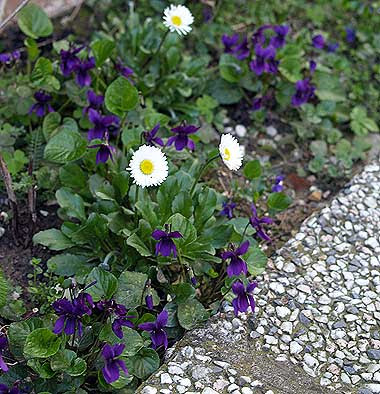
<box><xmin>105</xmin><ymin>77</ymin><xmax>139</xmax><ymax>117</ymax></box>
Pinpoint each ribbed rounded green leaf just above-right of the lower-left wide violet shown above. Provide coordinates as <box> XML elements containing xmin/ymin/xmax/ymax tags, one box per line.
<box><xmin>86</xmin><ymin>267</ymin><xmax>118</xmax><ymax>302</ymax></box>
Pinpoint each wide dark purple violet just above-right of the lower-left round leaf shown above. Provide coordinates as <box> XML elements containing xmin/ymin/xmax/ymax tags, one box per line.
<box><xmin>53</xmin><ymin>293</ymin><xmax>94</xmax><ymax>336</ymax></box>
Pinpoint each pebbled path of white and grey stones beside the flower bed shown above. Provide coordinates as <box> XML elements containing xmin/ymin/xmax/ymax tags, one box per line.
<box><xmin>138</xmin><ymin>161</ymin><xmax>380</xmax><ymax>394</ymax></box>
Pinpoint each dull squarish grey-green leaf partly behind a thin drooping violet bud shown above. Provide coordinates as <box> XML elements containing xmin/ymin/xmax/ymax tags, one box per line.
<box><xmin>115</xmin><ymin>271</ymin><xmax>160</xmax><ymax>309</ymax></box>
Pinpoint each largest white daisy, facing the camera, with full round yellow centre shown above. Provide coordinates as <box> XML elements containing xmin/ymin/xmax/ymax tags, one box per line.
<box><xmin>127</xmin><ymin>145</ymin><xmax>168</xmax><ymax>187</ymax></box>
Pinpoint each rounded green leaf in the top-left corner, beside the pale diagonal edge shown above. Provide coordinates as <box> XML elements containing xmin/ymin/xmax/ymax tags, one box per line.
<box><xmin>18</xmin><ymin>4</ymin><xmax>53</xmax><ymax>39</ymax></box>
